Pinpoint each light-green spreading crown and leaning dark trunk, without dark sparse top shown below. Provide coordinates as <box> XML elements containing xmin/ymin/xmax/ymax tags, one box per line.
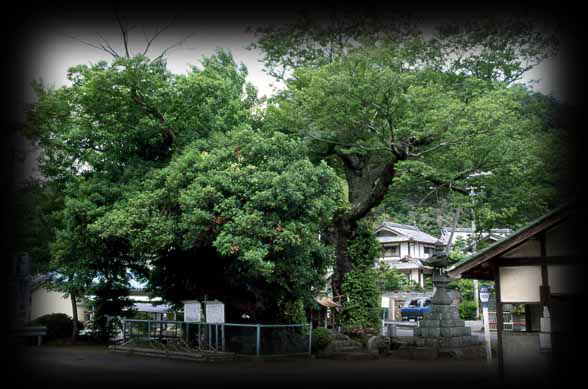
<box><xmin>266</xmin><ymin>48</ymin><xmax>552</xmax><ymax>308</ymax></box>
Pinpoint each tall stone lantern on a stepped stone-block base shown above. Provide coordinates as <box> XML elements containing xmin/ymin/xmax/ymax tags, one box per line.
<box><xmin>404</xmin><ymin>244</ymin><xmax>485</xmax><ymax>359</ymax></box>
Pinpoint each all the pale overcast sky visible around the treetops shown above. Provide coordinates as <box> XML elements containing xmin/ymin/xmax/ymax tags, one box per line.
<box><xmin>13</xmin><ymin>5</ymin><xmax>574</xmax><ymax>182</ymax></box>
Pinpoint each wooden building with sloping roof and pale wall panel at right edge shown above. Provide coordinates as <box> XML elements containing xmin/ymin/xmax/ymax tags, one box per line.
<box><xmin>448</xmin><ymin>204</ymin><xmax>585</xmax><ymax>381</ymax></box>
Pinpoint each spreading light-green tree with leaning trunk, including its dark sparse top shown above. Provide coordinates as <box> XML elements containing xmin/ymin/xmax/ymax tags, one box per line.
<box><xmin>259</xmin><ymin>12</ymin><xmax>564</xmax><ymax>312</ymax></box>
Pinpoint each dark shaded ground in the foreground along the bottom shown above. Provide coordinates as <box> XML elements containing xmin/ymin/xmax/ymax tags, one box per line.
<box><xmin>13</xmin><ymin>346</ymin><xmax>506</xmax><ymax>389</ymax></box>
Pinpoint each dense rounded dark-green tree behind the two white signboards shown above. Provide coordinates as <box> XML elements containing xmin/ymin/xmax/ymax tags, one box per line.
<box><xmin>91</xmin><ymin>130</ymin><xmax>340</xmax><ymax>321</ymax></box>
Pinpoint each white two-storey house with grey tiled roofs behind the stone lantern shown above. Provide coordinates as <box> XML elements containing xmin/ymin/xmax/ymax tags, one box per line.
<box><xmin>375</xmin><ymin>222</ymin><xmax>440</xmax><ymax>288</ymax></box>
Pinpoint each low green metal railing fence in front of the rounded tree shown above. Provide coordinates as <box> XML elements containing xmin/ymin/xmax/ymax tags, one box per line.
<box><xmin>121</xmin><ymin>320</ymin><xmax>312</xmax><ymax>356</ymax></box>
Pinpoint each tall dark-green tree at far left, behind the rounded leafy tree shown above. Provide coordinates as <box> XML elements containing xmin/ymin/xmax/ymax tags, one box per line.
<box><xmin>23</xmin><ymin>51</ymin><xmax>264</xmax><ymax>332</ymax></box>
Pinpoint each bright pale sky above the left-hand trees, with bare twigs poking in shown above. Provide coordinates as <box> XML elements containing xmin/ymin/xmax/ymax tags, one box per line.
<box><xmin>22</xmin><ymin>9</ymin><xmax>290</xmax><ymax>109</ymax></box>
